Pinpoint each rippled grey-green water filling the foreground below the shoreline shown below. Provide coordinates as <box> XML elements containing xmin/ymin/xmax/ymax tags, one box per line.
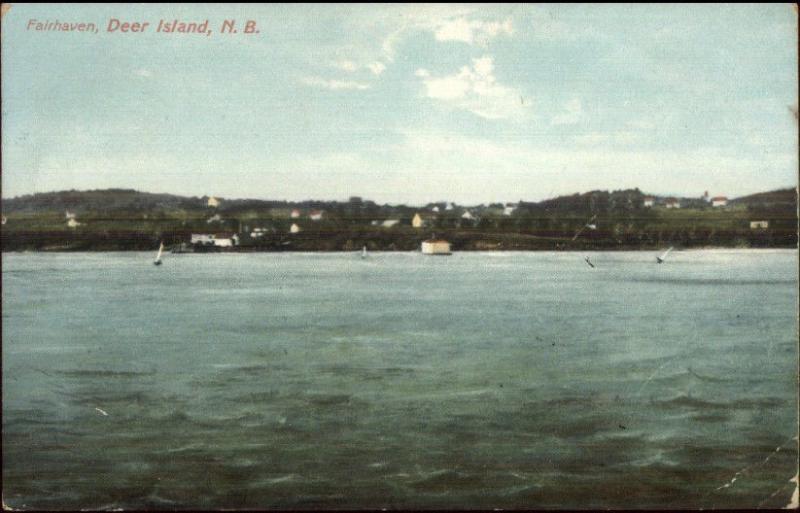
<box><xmin>2</xmin><ymin>250</ymin><xmax>798</xmax><ymax>509</ymax></box>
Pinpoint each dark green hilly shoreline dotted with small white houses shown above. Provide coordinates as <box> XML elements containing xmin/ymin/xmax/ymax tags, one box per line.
<box><xmin>2</xmin><ymin>189</ymin><xmax>797</xmax><ymax>253</ymax></box>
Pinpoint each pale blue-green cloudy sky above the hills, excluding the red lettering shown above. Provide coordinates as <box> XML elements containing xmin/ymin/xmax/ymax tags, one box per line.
<box><xmin>1</xmin><ymin>4</ymin><xmax>798</xmax><ymax>205</ymax></box>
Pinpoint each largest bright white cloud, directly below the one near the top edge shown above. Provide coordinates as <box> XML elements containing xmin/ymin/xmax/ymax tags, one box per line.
<box><xmin>415</xmin><ymin>56</ymin><xmax>526</xmax><ymax>119</ymax></box>
